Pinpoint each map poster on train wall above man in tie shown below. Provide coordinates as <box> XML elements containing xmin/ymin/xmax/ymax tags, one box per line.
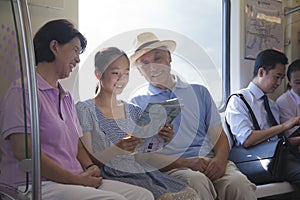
<box><xmin>245</xmin><ymin>0</ymin><xmax>283</xmax><ymax>59</ymax></box>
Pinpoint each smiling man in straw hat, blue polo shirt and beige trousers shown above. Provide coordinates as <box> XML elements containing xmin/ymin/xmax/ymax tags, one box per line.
<box><xmin>131</xmin><ymin>32</ymin><xmax>256</xmax><ymax>200</ymax></box>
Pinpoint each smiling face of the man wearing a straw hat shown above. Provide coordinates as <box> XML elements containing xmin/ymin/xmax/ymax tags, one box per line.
<box><xmin>136</xmin><ymin>49</ymin><xmax>172</xmax><ymax>86</ymax></box>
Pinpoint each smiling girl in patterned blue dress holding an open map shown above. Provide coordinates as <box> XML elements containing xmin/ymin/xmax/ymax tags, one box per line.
<box><xmin>76</xmin><ymin>47</ymin><xmax>199</xmax><ymax>200</ymax></box>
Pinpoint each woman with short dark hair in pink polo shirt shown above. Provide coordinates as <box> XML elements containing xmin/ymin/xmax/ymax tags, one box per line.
<box><xmin>0</xmin><ymin>19</ymin><xmax>153</xmax><ymax>200</ymax></box>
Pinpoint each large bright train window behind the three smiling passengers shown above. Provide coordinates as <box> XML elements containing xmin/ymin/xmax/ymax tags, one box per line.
<box><xmin>77</xmin><ymin>0</ymin><xmax>223</xmax><ymax>106</ymax></box>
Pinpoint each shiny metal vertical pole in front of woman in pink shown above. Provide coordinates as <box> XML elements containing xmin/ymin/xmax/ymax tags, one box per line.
<box><xmin>17</xmin><ymin>0</ymin><xmax>41</xmax><ymax>200</ymax></box>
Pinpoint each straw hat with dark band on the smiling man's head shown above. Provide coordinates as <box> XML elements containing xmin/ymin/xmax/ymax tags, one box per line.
<box><xmin>130</xmin><ymin>32</ymin><xmax>176</xmax><ymax>63</ymax></box>
